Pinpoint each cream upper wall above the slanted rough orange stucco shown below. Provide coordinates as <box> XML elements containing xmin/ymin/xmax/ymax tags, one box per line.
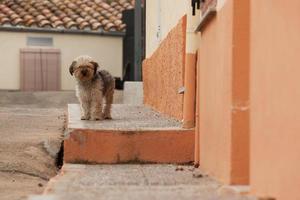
<box><xmin>146</xmin><ymin>0</ymin><xmax>200</xmax><ymax>58</ymax></box>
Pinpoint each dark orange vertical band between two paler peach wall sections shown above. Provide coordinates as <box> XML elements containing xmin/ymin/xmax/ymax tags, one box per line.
<box><xmin>231</xmin><ymin>0</ymin><xmax>250</xmax><ymax>184</ymax></box>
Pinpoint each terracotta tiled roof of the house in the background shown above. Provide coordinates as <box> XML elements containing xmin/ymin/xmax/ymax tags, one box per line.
<box><xmin>0</xmin><ymin>0</ymin><xmax>134</xmax><ymax>31</ymax></box>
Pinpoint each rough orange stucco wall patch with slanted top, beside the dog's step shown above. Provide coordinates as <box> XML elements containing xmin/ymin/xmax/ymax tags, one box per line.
<box><xmin>143</xmin><ymin>16</ymin><xmax>186</xmax><ymax>120</ymax></box>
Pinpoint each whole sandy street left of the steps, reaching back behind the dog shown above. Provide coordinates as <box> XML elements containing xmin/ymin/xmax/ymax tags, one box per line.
<box><xmin>0</xmin><ymin>91</ymin><xmax>122</xmax><ymax>200</ymax></box>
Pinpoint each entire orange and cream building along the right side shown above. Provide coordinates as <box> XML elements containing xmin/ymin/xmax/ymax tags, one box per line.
<box><xmin>143</xmin><ymin>0</ymin><xmax>300</xmax><ymax>200</ymax></box>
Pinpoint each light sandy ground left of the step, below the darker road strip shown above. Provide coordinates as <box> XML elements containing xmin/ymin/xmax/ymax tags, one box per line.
<box><xmin>0</xmin><ymin>107</ymin><xmax>65</xmax><ymax>200</ymax></box>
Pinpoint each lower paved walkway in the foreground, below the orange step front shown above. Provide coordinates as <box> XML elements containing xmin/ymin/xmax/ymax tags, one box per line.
<box><xmin>30</xmin><ymin>164</ymin><xmax>255</xmax><ymax>200</ymax></box>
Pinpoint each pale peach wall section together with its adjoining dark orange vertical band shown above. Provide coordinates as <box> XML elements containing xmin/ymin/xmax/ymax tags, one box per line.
<box><xmin>196</xmin><ymin>0</ymin><xmax>249</xmax><ymax>184</ymax></box>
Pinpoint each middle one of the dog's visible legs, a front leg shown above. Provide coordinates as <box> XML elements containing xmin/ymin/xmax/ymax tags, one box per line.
<box><xmin>91</xmin><ymin>89</ymin><xmax>103</xmax><ymax>120</ymax></box>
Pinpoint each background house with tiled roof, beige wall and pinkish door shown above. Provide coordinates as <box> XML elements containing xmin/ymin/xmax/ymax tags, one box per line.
<box><xmin>0</xmin><ymin>0</ymin><xmax>134</xmax><ymax>91</ymax></box>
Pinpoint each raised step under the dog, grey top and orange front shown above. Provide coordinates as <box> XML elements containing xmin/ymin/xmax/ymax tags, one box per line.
<box><xmin>64</xmin><ymin>104</ymin><xmax>194</xmax><ymax>163</ymax></box>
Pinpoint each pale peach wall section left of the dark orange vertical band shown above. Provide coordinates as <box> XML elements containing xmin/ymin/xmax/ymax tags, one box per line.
<box><xmin>198</xmin><ymin>1</ymin><xmax>233</xmax><ymax>183</ymax></box>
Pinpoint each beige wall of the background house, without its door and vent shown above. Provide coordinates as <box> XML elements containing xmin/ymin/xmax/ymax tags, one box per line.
<box><xmin>0</xmin><ymin>32</ymin><xmax>122</xmax><ymax>90</ymax></box>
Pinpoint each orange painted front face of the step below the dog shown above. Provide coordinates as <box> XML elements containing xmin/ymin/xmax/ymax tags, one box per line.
<box><xmin>64</xmin><ymin>129</ymin><xmax>195</xmax><ymax>163</ymax></box>
